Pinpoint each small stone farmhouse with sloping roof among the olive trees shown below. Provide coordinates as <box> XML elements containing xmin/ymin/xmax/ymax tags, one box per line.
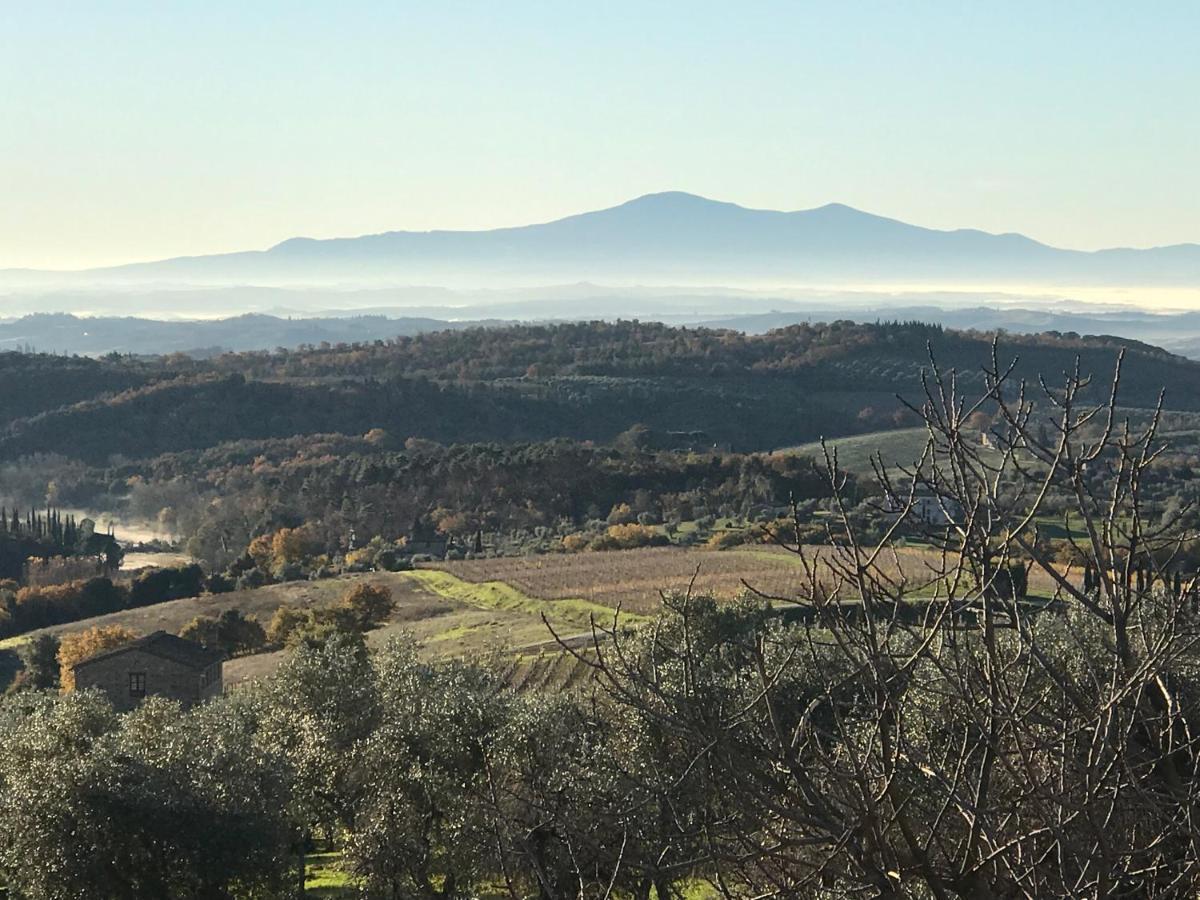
<box><xmin>74</xmin><ymin>631</ymin><xmax>223</xmax><ymax>713</ymax></box>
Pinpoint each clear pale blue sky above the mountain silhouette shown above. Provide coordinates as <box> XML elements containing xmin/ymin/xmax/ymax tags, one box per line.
<box><xmin>0</xmin><ymin>0</ymin><xmax>1200</xmax><ymax>269</ymax></box>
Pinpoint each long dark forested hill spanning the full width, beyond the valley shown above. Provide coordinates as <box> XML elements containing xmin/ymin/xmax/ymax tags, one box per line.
<box><xmin>0</xmin><ymin>322</ymin><xmax>1200</xmax><ymax>463</ymax></box>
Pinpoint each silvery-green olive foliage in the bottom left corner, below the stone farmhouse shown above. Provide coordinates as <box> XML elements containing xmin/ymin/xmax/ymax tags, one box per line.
<box><xmin>0</xmin><ymin>691</ymin><xmax>290</xmax><ymax>900</ymax></box>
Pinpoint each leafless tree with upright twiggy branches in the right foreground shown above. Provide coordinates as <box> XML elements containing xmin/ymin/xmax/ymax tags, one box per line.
<box><xmin>559</xmin><ymin>347</ymin><xmax>1200</xmax><ymax>898</ymax></box>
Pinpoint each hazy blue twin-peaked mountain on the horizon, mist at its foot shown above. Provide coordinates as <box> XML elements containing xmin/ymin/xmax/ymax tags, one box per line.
<box><xmin>9</xmin><ymin>192</ymin><xmax>1200</xmax><ymax>286</ymax></box>
